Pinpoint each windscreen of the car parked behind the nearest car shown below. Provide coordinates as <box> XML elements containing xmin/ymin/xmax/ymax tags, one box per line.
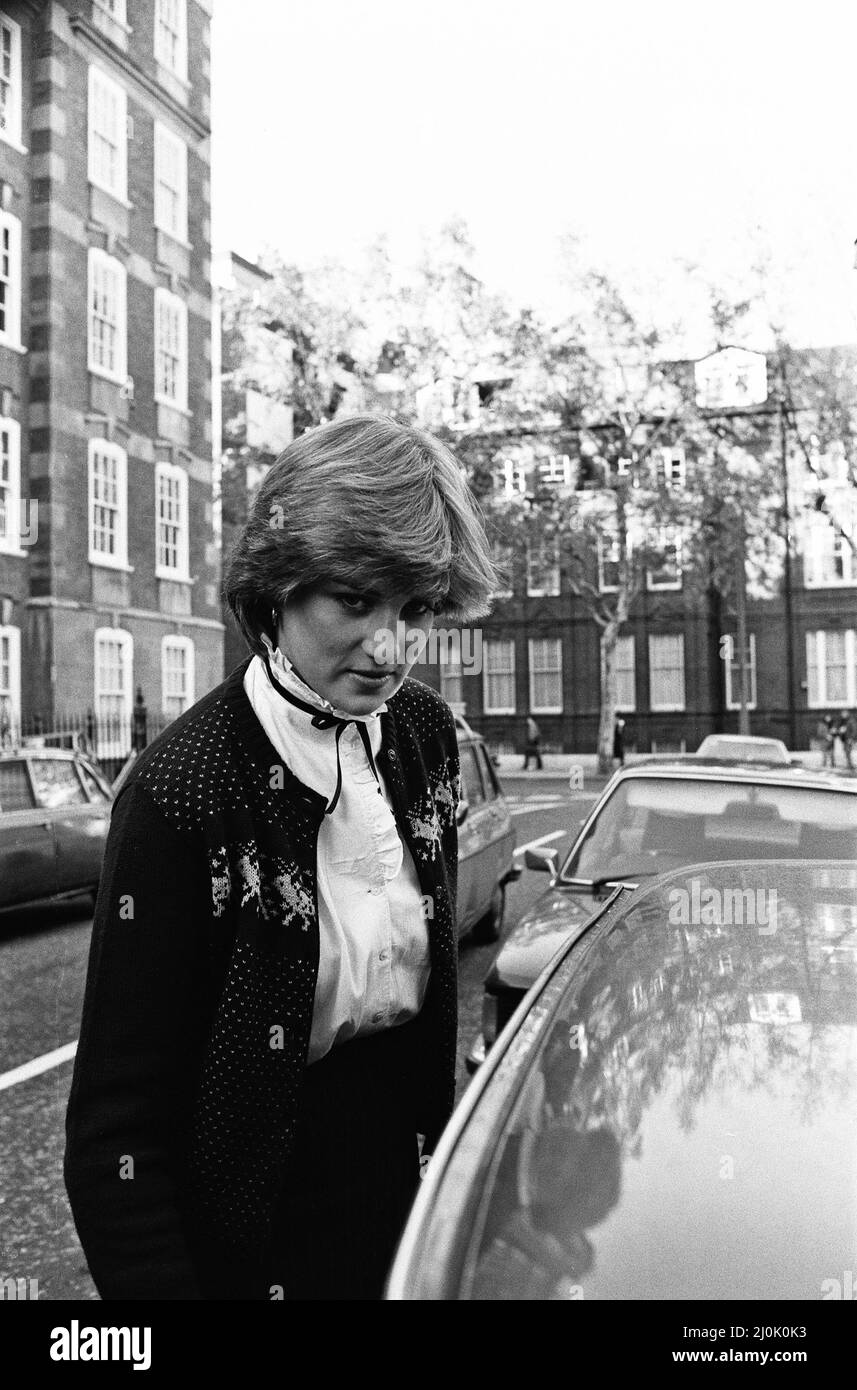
<box><xmin>563</xmin><ymin>777</ymin><xmax>857</xmax><ymax>878</ymax></box>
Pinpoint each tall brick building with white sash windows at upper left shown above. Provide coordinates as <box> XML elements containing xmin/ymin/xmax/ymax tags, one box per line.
<box><xmin>0</xmin><ymin>0</ymin><xmax>224</xmax><ymax>756</ymax></box>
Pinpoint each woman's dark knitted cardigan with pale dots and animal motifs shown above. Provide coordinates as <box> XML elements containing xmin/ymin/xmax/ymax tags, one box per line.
<box><xmin>65</xmin><ymin>659</ymin><xmax>460</xmax><ymax>1298</ymax></box>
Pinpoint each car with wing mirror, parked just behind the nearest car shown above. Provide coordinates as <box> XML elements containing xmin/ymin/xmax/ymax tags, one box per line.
<box><xmin>467</xmin><ymin>758</ymin><xmax>857</xmax><ymax>1070</ymax></box>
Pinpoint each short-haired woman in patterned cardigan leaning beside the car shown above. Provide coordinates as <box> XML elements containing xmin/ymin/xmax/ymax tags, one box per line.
<box><xmin>65</xmin><ymin>416</ymin><xmax>497</xmax><ymax>1300</ymax></box>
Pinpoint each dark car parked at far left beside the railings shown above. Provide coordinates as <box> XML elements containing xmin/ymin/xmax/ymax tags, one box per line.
<box><xmin>0</xmin><ymin>746</ymin><xmax>114</xmax><ymax>908</ymax></box>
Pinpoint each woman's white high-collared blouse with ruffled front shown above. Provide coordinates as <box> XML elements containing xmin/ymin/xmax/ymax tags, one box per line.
<box><xmin>244</xmin><ymin>638</ymin><xmax>429</xmax><ymax>1062</ymax></box>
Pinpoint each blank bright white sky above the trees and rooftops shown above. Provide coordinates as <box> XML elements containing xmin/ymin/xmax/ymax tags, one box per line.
<box><xmin>211</xmin><ymin>0</ymin><xmax>857</xmax><ymax>346</ymax></box>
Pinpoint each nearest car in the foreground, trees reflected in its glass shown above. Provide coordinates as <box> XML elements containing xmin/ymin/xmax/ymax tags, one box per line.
<box><xmin>385</xmin><ymin>859</ymin><xmax>857</xmax><ymax>1302</ymax></box>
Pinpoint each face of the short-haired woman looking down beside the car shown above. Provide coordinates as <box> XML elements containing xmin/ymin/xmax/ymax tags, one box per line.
<box><xmin>278</xmin><ymin>582</ymin><xmax>435</xmax><ymax>714</ymax></box>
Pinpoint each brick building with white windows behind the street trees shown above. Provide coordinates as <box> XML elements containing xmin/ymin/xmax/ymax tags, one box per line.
<box><xmin>424</xmin><ymin>348</ymin><xmax>857</xmax><ymax>752</ymax></box>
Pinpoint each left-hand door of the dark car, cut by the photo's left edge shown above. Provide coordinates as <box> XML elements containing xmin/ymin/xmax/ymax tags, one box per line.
<box><xmin>0</xmin><ymin>758</ymin><xmax>57</xmax><ymax>908</ymax></box>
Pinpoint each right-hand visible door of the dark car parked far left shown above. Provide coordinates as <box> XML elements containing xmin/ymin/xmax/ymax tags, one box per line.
<box><xmin>31</xmin><ymin>756</ymin><xmax>110</xmax><ymax>892</ymax></box>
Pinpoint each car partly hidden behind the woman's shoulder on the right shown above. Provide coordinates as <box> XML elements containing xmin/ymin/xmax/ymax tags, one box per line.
<box><xmin>456</xmin><ymin>716</ymin><xmax>521</xmax><ymax>944</ymax></box>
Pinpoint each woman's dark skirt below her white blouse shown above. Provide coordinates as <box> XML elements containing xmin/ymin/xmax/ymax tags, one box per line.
<box><xmin>191</xmin><ymin>1023</ymin><xmax>419</xmax><ymax>1301</ymax></box>
